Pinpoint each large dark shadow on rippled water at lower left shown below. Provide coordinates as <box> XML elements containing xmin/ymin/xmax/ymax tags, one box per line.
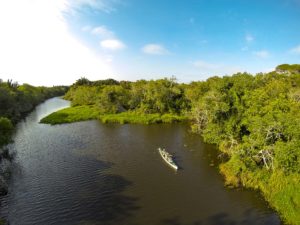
<box><xmin>4</xmin><ymin>157</ymin><xmax>139</xmax><ymax>225</ymax></box>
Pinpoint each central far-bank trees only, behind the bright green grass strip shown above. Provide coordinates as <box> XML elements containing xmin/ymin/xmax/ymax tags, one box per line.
<box><xmin>65</xmin><ymin>78</ymin><xmax>189</xmax><ymax>114</ymax></box>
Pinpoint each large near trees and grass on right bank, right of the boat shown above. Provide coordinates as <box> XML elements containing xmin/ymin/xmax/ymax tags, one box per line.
<box><xmin>186</xmin><ymin>65</ymin><xmax>300</xmax><ymax>224</ymax></box>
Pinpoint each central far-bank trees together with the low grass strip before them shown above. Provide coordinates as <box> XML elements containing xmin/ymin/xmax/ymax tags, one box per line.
<box><xmin>42</xmin><ymin>78</ymin><xmax>190</xmax><ymax>124</ymax></box>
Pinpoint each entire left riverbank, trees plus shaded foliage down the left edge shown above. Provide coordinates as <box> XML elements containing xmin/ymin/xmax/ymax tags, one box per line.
<box><xmin>0</xmin><ymin>79</ymin><xmax>67</xmax><ymax>225</ymax></box>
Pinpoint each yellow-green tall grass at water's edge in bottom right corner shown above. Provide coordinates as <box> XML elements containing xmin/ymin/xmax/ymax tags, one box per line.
<box><xmin>220</xmin><ymin>157</ymin><xmax>300</xmax><ymax>224</ymax></box>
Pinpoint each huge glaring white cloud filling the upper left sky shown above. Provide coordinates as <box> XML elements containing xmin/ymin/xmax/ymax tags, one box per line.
<box><xmin>0</xmin><ymin>0</ymin><xmax>113</xmax><ymax>85</ymax></box>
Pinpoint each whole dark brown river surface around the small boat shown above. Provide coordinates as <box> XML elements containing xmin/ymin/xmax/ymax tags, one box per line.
<box><xmin>1</xmin><ymin>98</ymin><xmax>280</xmax><ymax>225</ymax></box>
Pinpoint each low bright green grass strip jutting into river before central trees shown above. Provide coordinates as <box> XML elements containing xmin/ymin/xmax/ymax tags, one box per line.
<box><xmin>41</xmin><ymin>105</ymin><xmax>187</xmax><ymax>125</ymax></box>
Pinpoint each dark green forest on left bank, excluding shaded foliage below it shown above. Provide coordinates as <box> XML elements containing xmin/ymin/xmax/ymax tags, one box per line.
<box><xmin>0</xmin><ymin>79</ymin><xmax>67</xmax><ymax>148</ymax></box>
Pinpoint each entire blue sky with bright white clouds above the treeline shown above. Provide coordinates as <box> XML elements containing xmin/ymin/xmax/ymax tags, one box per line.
<box><xmin>0</xmin><ymin>0</ymin><xmax>300</xmax><ymax>86</ymax></box>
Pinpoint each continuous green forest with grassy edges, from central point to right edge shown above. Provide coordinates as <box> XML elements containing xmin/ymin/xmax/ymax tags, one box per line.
<box><xmin>42</xmin><ymin>64</ymin><xmax>300</xmax><ymax>224</ymax></box>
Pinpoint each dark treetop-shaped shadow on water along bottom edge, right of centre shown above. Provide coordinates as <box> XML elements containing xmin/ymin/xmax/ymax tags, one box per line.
<box><xmin>158</xmin><ymin>210</ymin><xmax>280</xmax><ymax>225</ymax></box>
